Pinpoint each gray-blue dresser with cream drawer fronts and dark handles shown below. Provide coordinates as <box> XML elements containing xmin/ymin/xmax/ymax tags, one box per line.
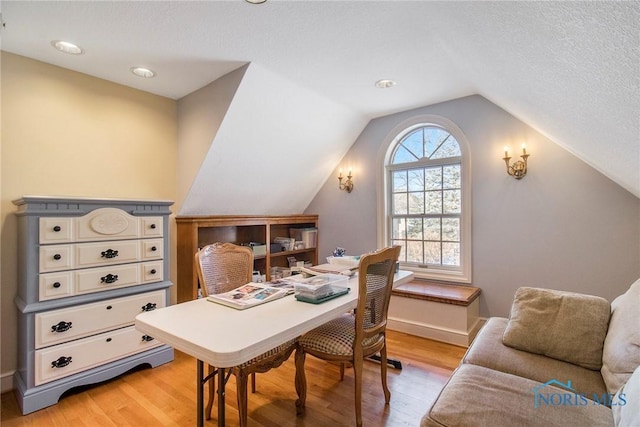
<box><xmin>13</xmin><ymin>196</ymin><xmax>173</xmax><ymax>414</ymax></box>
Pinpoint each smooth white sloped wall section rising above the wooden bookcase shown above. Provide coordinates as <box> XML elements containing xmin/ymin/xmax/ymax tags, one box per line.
<box><xmin>180</xmin><ymin>63</ymin><xmax>366</xmax><ymax>215</ymax></box>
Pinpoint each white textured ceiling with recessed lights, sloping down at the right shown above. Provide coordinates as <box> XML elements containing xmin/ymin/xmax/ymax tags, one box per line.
<box><xmin>1</xmin><ymin>0</ymin><xmax>640</xmax><ymax>197</ymax></box>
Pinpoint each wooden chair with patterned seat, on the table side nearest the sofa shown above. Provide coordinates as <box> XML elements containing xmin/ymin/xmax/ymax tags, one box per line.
<box><xmin>295</xmin><ymin>246</ymin><xmax>400</xmax><ymax>426</ymax></box>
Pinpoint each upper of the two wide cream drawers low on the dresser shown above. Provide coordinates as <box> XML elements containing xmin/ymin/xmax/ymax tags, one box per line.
<box><xmin>35</xmin><ymin>291</ymin><xmax>165</xmax><ymax>349</ymax></box>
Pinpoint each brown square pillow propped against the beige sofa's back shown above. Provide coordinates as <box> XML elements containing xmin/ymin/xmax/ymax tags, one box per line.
<box><xmin>502</xmin><ymin>287</ymin><xmax>611</xmax><ymax>370</ymax></box>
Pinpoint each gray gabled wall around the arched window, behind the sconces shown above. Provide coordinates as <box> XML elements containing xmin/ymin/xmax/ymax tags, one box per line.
<box><xmin>305</xmin><ymin>95</ymin><xmax>640</xmax><ymax>317</ymax></box>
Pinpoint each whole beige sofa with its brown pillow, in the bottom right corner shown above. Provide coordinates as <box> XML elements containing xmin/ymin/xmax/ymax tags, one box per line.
<box><xmin>421</xmin><ymin>279</ymin><xmax>640</xmax><ymax>427</ymax></box>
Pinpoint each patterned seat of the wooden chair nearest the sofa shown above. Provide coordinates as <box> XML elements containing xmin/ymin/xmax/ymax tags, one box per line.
<box><xmin>298</xmin><ymin>314</ymin><xmax>382</xmax><ymax>356</ymax></box>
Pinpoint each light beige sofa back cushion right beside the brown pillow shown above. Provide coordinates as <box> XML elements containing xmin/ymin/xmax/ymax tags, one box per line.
<box><xmin>602</xmin><ymin>279</ymin><xmax>640</xmax><ymax>394</ymax></box>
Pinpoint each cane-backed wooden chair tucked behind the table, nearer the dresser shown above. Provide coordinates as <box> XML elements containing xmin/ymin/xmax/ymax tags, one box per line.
<box><xmin>195</xmin><ymin>243</ymin><xmax>296</xmax><ymax>427</ymax></box>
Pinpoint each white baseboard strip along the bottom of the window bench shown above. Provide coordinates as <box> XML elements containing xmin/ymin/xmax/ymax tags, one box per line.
<box><xmin>387</xmin><ymin>317</ymin><xmax>487</xmax><ymax>347</ymax></box>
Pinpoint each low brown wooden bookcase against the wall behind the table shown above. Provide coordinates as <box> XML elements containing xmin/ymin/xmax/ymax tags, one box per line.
<box><xmin>176</xmin><ymin>215</ymin><xmax>318</xmax><ymax>302</ymax></box>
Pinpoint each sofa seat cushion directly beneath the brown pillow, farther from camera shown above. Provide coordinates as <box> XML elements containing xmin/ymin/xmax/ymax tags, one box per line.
<box><xmin>462</xmin><ymin>317</ymin><xmax>607</xmax><ymax>396</ymax></box>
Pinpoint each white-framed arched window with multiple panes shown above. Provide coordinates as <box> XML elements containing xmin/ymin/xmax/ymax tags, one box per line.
<box><xmin>384</xmin><ymin>119</ymin><xmax>471</xmax><ymax>282</ymax></box>
